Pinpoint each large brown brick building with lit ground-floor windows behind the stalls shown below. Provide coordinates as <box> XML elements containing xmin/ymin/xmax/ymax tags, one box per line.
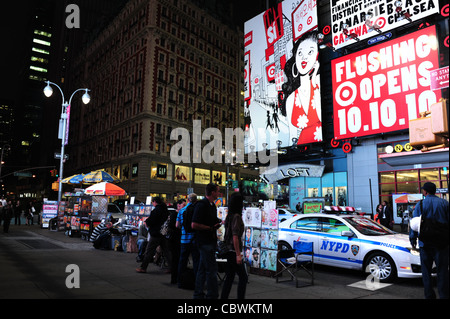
<box><xmin>65</xmin><ymin>0</ymin><xmax>243</xmax><ymax>201</ymax></box>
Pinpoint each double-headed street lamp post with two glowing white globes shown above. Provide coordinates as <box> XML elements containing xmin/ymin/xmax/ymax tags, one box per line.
<box><xmin>44</xmin><ymin>81</ymin><xmax>91</xmax><ymax>208</ymax></box>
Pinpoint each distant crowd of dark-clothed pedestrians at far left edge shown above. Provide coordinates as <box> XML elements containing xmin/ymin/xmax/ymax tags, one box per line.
<box><xmin>0</xmin><ymin>197</ymin><xmax>36</xmax><ymax>233</ymax></box>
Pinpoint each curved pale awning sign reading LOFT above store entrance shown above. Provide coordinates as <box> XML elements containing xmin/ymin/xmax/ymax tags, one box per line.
<box><xmin>261</xmin><ymin>163</ymin><xmax>325</xmax><ymax>183</ymax></box>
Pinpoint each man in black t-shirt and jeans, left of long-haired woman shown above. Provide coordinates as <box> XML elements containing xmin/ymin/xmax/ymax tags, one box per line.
<box><xmin>192</xmin><ymin>183</ymin><xmax>221</xmax><ymax>299</ymax></box>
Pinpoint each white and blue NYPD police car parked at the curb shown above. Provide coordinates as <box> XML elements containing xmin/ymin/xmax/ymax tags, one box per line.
<box><xmin>279</xmin><ymin>214</ymin><xmax>422</xmax><ymax>282</ymax></box>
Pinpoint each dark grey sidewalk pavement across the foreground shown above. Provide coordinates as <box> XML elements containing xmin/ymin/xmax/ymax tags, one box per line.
<box><xmin>0</xmin><ymin>224</ymin><xmax>423</xmax><ymax>301</ymax></box>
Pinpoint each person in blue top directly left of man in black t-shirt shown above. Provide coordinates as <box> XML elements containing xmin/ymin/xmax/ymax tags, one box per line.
<box><xmin>176</xmin><ymin>193</ymin><xmax>199</xmax><ymax>289</ymax></box>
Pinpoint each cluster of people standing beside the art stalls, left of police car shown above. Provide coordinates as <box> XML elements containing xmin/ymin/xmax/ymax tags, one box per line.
<box><xmin>132</xmin><ymin>183</ymin><xmax>248</xmax><ymax>299</ymax></box>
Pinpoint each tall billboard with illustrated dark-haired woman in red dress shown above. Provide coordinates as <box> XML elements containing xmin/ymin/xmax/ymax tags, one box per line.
<box><xmin>244</xmin><ymin>0</ymin><xmax>322</xmax><ymax>153</ymax></box>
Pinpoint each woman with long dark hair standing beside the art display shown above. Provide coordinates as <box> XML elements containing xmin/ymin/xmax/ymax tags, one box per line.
<box><xmin>221</xmin><ymin>193</ymin><xmax>248</xmax><ymax>299</ymax></box>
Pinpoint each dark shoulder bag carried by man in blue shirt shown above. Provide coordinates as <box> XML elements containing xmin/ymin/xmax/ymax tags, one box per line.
<box><xmin>419</xmin><ymin>201</ymin><xmax>449</xmax><ymax>248</ymax></box>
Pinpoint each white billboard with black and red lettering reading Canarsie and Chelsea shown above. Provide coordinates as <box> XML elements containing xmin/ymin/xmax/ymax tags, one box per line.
<box><xmin>330</xmin><ymin>0</ymin><xmax>439</xmax><ymax>49</ymax></box>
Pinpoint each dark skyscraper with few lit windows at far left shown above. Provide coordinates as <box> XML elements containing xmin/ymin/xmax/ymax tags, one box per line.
<box><xmin>0</xmin><ymin>0</ymin><xmax>130</xmax><ymax>200</ymax></box>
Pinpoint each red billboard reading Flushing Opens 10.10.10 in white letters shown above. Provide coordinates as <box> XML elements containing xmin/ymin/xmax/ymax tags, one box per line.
<box><xmin>331</xmin><ymin>26</ymin><xmax>441</xmax><ymax>140</ymax></box>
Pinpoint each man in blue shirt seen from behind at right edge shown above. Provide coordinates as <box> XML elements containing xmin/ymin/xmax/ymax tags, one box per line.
<box><xmin>409</xmin><ymin>182</ymin><xmax>449</xmax><ymax>299</ymax></box>
